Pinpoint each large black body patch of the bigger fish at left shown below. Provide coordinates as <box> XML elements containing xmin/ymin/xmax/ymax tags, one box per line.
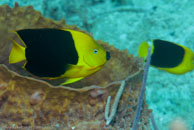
<box><xmin>17</xmin><ymin>29</ymin><xmax>78</xmax><ymax>77</ymax></box>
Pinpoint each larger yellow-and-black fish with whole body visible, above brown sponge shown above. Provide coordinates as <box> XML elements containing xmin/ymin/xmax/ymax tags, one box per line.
<box><xmin>9</xmin><ymin>28</ymin><xmax>110</xmax><ymax>85</ymax></box>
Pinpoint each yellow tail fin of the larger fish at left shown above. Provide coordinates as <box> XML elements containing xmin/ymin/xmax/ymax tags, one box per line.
<box><xmin>9</xmin><ymin>39</ymin><xmax>26</xmax><ymax>64</ymax></box>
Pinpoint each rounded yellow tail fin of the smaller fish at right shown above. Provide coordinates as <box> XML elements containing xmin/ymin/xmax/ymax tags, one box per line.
<box><xmin>138</xmin><ymin>42</ymin><xmax>149</xmax><ymax>57</ymax></box>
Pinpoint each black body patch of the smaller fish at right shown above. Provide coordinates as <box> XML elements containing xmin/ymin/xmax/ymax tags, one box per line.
<box><xmin>151</xmin><ymin>40</ymin><xmax>185</xmax><ymax>68</ymax></box>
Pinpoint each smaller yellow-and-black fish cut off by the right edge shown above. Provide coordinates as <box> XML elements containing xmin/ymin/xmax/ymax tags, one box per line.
<box><xmin>138</xmin><ymin>39</ymin><xmax>194</xmax><ymax>74</ymax></box>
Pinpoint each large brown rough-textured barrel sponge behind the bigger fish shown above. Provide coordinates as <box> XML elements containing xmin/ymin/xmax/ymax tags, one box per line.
<box><xmin>0</xmin><ymin>4</ymin><xmax>150</xmax><ymax>130</ymax></box>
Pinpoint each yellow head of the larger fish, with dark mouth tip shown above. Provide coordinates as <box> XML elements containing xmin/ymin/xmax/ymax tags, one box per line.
<box><xmin>65</xmin><ymin>30</ymin><xmax>110</xmax><ymax>69</ymax></box>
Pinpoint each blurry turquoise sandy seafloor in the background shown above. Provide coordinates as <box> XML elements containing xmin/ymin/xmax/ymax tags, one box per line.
<box><xmin>0</xmin><ymin>0</ymin><xmax>194</xmax><ymax>130</ymax></box>
